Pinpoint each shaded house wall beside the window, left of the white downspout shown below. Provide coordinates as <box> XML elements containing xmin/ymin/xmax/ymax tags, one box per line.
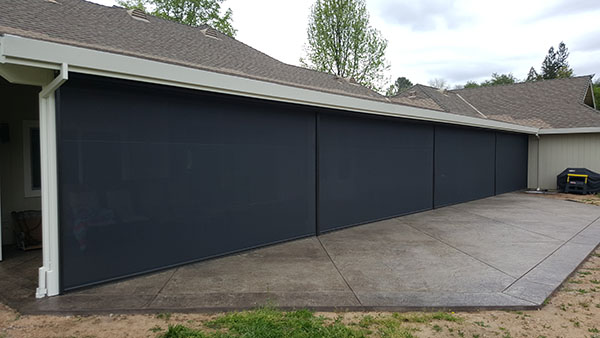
<box><xmin>0</xmin><ymin>80</ymin><xmax>41</xmax><ymax>244</ymax></box>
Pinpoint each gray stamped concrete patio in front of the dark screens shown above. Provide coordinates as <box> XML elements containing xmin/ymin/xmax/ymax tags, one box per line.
<box><xmin>0</xmin><ymin>193</ymin><xmax>600</xmax><ymax>313</ymax></box>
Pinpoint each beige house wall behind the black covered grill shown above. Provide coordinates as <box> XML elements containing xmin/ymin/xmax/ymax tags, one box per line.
<box><xmin>527</xmin><ymin>133</ymin><xmax>600</xmax><ymax>189</ymax></box>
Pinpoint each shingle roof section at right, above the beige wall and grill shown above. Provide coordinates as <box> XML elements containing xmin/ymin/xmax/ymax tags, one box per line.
<box><xmin>391</xmin><ymin>76</ymin><xmax>600</xmax><ymax>128</ymax></box>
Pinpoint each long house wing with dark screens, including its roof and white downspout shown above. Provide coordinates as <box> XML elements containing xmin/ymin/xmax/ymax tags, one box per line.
<box><xmin>0</xmin><ymin>0</ymin><xmax>588</xmax><ymax>297</ymax></box>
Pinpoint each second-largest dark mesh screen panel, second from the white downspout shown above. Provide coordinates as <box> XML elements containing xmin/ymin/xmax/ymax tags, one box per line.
<box><xmin>318</xmin><ymin>114</ymin><xmax>433</xmax><ymax>231</ymax></box>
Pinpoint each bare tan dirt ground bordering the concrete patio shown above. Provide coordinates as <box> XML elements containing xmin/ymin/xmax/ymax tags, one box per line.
<box><xmin>0</xmin><ymin>194</ymin><xmax>600</xmax><ymax>338</ymax></box>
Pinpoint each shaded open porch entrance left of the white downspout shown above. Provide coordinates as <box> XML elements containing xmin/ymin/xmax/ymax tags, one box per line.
<box><xmin>0</xmin><ymin>77</ymin><xmax>42</xmax><ymax>293</ymax></box>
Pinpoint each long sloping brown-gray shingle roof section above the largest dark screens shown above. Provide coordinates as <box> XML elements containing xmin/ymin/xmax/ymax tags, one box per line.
<box><xmin>0</xmin><ymin>0</ymin><xmax>386</xmax><ymax>101</ymax></box>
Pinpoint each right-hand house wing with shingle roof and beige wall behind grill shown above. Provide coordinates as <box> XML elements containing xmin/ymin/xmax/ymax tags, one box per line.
<box><xmin>392</xmin><ymin>75</ymin><xmax>600</xmax><ymax>190</ymax></box>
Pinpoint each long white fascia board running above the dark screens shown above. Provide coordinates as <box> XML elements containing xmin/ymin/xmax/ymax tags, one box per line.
<box><xmin>0</xmin><ymin>35</ymin><xmax>538</xmax><ymax>134</ymax></box>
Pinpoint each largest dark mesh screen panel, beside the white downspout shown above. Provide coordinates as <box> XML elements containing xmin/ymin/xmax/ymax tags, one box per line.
<box><xmin>58</xmin><ymin>75</ymin><xmax>315</xmax><ymax>290</ymax></box>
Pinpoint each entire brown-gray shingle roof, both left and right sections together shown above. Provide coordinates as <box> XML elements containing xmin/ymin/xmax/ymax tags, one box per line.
<box><xmin>0</xmin><ymin>0</ymin><xmax>600</xmax><ymax>128</ymax></box>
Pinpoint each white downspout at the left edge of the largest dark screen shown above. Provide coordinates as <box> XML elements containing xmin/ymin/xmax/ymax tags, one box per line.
<box><xmin>35</xmin><ymin>63</ymin><xmax>69</xmax><ymax>298</ymax></box>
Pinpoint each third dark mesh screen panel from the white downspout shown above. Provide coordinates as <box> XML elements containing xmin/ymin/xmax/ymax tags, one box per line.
<box><xmin>434</xmin><ymin>126</ymin><xmax>495</xmax><ymax>208</ymax></box>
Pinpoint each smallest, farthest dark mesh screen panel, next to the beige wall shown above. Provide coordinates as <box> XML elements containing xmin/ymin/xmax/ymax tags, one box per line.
<box><xmin>496</xmin><ymin>133</ymin><xmax>528</xmax><ymax>194</ymax></box>
